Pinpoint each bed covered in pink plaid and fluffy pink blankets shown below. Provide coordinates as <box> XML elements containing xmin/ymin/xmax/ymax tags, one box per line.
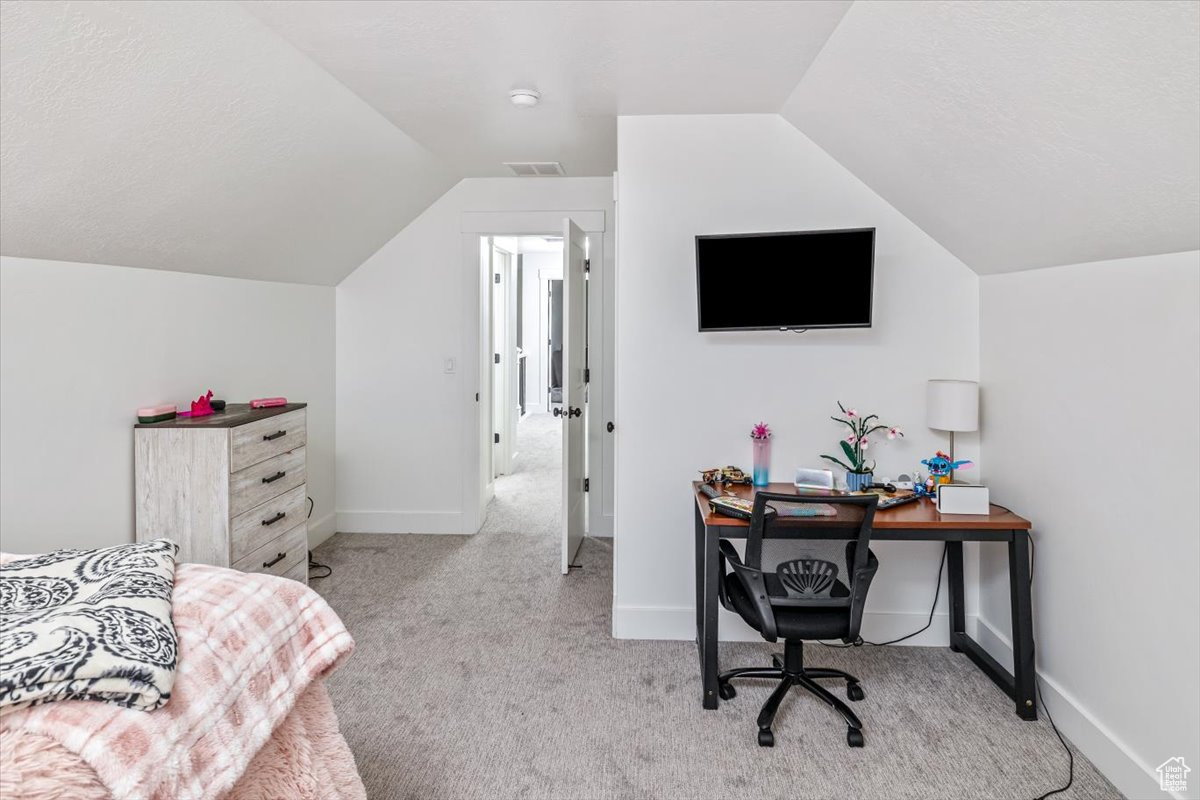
<box><xmin>0</xmin><ymin>555</ymin><xmax>366</xmax><ymax>800</ymax></box>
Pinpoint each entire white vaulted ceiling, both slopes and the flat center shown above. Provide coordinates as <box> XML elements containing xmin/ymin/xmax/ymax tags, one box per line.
<box><xmin>0</xmin><ymin>0</ymin><xmax>1200</xmax><ymax>284</ymax></box>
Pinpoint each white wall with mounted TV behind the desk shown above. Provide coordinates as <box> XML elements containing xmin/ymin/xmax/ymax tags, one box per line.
<box><xmin>613</xmin><ymin>114</ymin><xmax>979</xmax><ymax>644</ymax></box>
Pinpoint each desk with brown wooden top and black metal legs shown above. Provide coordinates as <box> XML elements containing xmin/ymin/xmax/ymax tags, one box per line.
<box><xmin>691</xmin><ymin>482</ymin><xmax>1038</xmax><ymax>720</ymax></box>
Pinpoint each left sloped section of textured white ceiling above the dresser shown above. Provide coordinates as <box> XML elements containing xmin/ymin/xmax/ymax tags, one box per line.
<box><xmin>0</xmin><ymin>2</ymin><xmax>456</xmax><ymax>284</ymax></box>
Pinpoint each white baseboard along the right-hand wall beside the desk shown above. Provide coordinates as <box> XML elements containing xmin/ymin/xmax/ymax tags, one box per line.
<box><xmin>974</xmin><ymin>618</ymin><xmax>1186</xmax><ymax>800</ymax></box>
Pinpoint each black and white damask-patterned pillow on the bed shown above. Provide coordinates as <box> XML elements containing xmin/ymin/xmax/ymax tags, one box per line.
<box><xmin>0</xmin><ymin>539</ymin><xmax>179</xmax><ymax>715</ymax></box>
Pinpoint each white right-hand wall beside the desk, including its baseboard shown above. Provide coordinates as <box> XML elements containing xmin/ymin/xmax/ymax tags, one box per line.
<box><xmin>979</xmin><ymin>252</ymin><xmax>1200</xmax><ymax>798</ymax></box>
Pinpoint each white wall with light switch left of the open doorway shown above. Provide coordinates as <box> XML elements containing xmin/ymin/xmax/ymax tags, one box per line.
<box><xmin>337</xmin><ymin>178</ymin><xmax>616</xmax><ymax>533</ymax></box>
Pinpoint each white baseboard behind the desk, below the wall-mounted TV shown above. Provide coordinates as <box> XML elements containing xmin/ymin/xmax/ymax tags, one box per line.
<box><xmin>612</xmin><ymin>606</ymin><xmax>960</xmax><ymax>648</ymax></box>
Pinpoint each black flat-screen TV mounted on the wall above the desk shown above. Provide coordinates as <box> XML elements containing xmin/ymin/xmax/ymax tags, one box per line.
<box><xmin>696</xmin><ymin>228</ymin><xmax>875</xmax><ymax>331</ymax></box>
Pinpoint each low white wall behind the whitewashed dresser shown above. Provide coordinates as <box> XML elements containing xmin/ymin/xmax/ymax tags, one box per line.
<box><xmin>0</xmin><ymin>258</ymin><xmax>335</xmax><ymax>553</ymax></box>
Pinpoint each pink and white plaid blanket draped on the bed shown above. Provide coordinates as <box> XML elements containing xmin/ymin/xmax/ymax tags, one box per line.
<box><xmin>0</xmin><ymin>557</ymin><xmax>361</xmax><ymax>800</ymax></box>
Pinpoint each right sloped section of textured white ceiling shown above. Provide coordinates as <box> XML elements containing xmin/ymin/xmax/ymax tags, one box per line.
<box><xmin>782</xmin><ymin>1</ymin><xmax>1200</xmax><ymax>273</ymax></box>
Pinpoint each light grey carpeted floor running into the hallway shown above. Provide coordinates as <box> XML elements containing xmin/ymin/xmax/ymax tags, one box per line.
<box><xmin>312</xmin><ymin>419</ymin><xmax>1120</xmax><ymax>800</ymax></box>
